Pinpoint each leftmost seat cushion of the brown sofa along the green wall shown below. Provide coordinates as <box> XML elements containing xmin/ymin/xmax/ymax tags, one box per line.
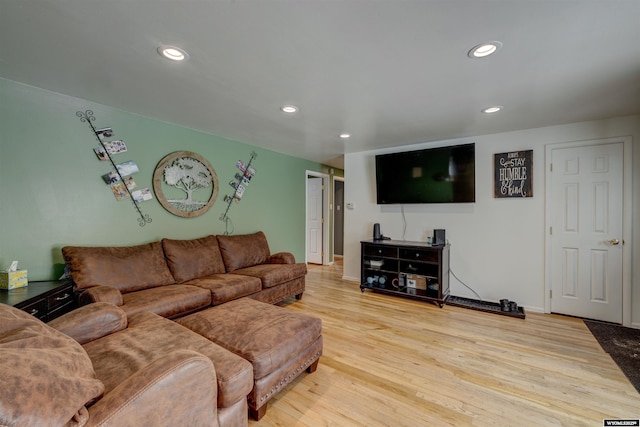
<box><xmin>120</xmin><ymin>285</ymin><xmax>211</xmax><ymax>318</ymax></box>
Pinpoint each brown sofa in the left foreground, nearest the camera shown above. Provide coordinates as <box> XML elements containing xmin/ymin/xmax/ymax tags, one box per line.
<box><xmin>0</xmin><ymin>303</ymin><xmax>253</xmax><ymax>427</ymax></box>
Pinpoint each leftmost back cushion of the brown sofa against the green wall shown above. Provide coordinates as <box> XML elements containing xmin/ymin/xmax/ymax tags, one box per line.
<box><xmin>62</xmin><ymin>242</ymin><xmax>175</xmax><ymax>292</ymax></box>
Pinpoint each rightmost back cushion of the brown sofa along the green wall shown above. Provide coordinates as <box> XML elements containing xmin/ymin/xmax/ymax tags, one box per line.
<box><xmin>218</xmin><ymin>231</ymin><xmax>271</xmax><ymax>273</ymax></box>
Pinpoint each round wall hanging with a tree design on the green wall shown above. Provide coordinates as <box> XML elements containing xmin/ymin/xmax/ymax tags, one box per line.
<box><xmin>153</xmin><ymin>151</ymin><xmax>218</xmax><ymax>218</ymax></box>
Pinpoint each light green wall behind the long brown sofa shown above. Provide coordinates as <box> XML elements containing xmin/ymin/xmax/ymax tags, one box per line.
<box><xmin>0</xmin><ymin>79</ymin><xmax>326</xmax><ymax>280</ymax></box>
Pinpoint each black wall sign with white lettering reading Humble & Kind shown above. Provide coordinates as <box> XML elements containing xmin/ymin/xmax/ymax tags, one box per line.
<box><xmin>493</xmin><ymin>150</ymin><xmax>533</xmax><ymax>198</ymax></box>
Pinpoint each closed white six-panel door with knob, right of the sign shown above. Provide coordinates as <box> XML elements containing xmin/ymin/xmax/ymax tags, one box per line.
<box><xmin>549</xmin><ymin>142</ymin><xmax>624</xmax><ymax>323</ymax></box>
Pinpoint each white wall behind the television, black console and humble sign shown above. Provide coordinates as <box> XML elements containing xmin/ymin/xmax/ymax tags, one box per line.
<box><xmin>344</xmin><ymin>116</ymin><xmax>640</xmax><ymax>327</ymax></box>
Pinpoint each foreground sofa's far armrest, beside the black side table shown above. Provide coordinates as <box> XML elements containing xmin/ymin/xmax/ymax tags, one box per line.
<box><xmin>48</xmin><ymin>302</ymin><xmax>127</xmax><ymax>344</ymax></box>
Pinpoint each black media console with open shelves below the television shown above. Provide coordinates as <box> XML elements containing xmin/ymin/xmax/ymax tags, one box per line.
<box><xmin>360</xmin><ymin>240</ymin><xmax>449</xmax><ymax>308</ymax></box>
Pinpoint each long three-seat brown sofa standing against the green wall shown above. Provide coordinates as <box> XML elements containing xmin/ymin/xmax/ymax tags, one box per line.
<box><xmin>62</xmin><ymin>231</ymin><xmax>307</xmax><ymax>319</ymax></box>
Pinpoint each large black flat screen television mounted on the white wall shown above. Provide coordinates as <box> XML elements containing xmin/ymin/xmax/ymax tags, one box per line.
<box><xmin>376</xmin><ymin>143</ymin><xmax>476</xmax><ymax>205</ymax></box>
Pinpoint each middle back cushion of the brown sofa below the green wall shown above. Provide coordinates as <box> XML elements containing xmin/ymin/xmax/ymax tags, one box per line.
<box><xmin>162</xmin><ymin>236</ymin><xmax>224</xmax><ymax>283</ymax></box>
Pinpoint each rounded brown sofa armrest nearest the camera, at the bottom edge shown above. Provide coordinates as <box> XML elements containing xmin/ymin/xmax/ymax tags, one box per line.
<box><xmin>87</xmin><ymin>350</ymin><xmax>218</xmax><ymax>426</ymax></box>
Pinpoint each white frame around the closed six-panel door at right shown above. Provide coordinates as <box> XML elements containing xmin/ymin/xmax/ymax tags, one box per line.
<box><xmin>544</xmin><ymin>136</ymin><xmax>633</xmax><ymax>326</ymax></box>
